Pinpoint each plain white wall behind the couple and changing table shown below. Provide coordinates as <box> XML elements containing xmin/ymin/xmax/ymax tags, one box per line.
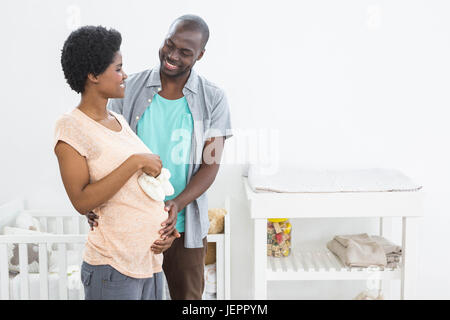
<box><xmin>0</xmin><ymin>0</ymin><xmax>450</xmax><ymax>299</ymax></box>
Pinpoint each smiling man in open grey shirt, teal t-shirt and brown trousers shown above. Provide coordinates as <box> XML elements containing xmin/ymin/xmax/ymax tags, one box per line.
<box><xmin>89</xmin><ymin>15</ymin><xmax>231</xmax><ymax>299</ymax></box>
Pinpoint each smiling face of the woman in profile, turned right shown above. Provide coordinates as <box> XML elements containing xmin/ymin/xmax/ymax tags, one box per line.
<box><xmin>97</xmin><ymin>51</ymin><xmax>128</xmax><ymax>98</ymax></box>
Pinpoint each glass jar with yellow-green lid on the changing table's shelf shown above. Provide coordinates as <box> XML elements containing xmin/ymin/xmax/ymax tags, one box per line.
<box><xmin>267</xmin><ymin>218</ymin><xmax>292</xmax><ymax>258</ymax></box>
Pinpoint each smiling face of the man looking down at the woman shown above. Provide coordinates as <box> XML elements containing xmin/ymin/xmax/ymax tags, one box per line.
<box><xmin>159</xmin><ymin>24</ymin><xmax>204</xmax><ymax>77</ymax></box>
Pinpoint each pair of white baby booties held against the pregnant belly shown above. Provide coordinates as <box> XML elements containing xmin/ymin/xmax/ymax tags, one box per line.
<box><xmin>138</xmin><ymin>168</ymin><xmax>175</xmax><ymax>201</ymax></box>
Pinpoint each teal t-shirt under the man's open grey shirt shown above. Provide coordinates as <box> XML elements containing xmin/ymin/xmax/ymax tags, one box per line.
<box><xmin>136</xmin><ymin>94</ymin><xmax>194</xmax><ymax>232</ymax></box>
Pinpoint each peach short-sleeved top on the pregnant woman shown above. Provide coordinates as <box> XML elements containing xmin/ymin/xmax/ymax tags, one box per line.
<box><xmin>53</xmin><ymin>108</ymin><xmax>167</xmax><ymax>278</ymax></box>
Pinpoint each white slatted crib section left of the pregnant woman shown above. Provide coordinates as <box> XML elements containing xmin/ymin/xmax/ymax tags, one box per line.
<box><xmin>0</xmin><ymin>199</ymin><xmax>89</xmax><ymax>300</ymax></box>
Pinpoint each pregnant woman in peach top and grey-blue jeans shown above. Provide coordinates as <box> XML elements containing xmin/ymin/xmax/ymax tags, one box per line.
<box><xmin>54</xmin><ymin>26</ymin><xmax>180</xmax><ymax>300</ymax></box>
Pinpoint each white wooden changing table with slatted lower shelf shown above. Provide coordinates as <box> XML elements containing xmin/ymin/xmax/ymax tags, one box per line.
<box><xmin>243</xmin><ymin>177</ymin><xmax>423</xmax><ymax>299</ymax></box>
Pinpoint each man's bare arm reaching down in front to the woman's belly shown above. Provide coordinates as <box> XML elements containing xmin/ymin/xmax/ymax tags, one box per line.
<box><xmin>160</xmin><ymin>137</ymin><xmax>225</xmax><ymax>239</ymax></box>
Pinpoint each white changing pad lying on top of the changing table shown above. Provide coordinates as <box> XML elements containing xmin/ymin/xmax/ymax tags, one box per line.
<box><xmin>248</xmin><ymin>166</ymin><xmax>422</xmax><ymax>193</ymax></box>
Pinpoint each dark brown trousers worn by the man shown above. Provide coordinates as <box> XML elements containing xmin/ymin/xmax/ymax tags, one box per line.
<box><xmin>163</xmin><ymin>232</ymin><xmax>208</xmax><ymax>300</ymax></box>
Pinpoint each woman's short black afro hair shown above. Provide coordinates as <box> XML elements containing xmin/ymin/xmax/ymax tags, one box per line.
<box><xmin>61</xmin><ymin>26</ymin><xmax>122</xmax><ymax>93</ymax></box>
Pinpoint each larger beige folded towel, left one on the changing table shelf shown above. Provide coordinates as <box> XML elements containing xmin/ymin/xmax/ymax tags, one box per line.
<box><xmin>327</xmin><ymin>233</ymin><xmax>387</xmax><ymax>267</ymax></box>
